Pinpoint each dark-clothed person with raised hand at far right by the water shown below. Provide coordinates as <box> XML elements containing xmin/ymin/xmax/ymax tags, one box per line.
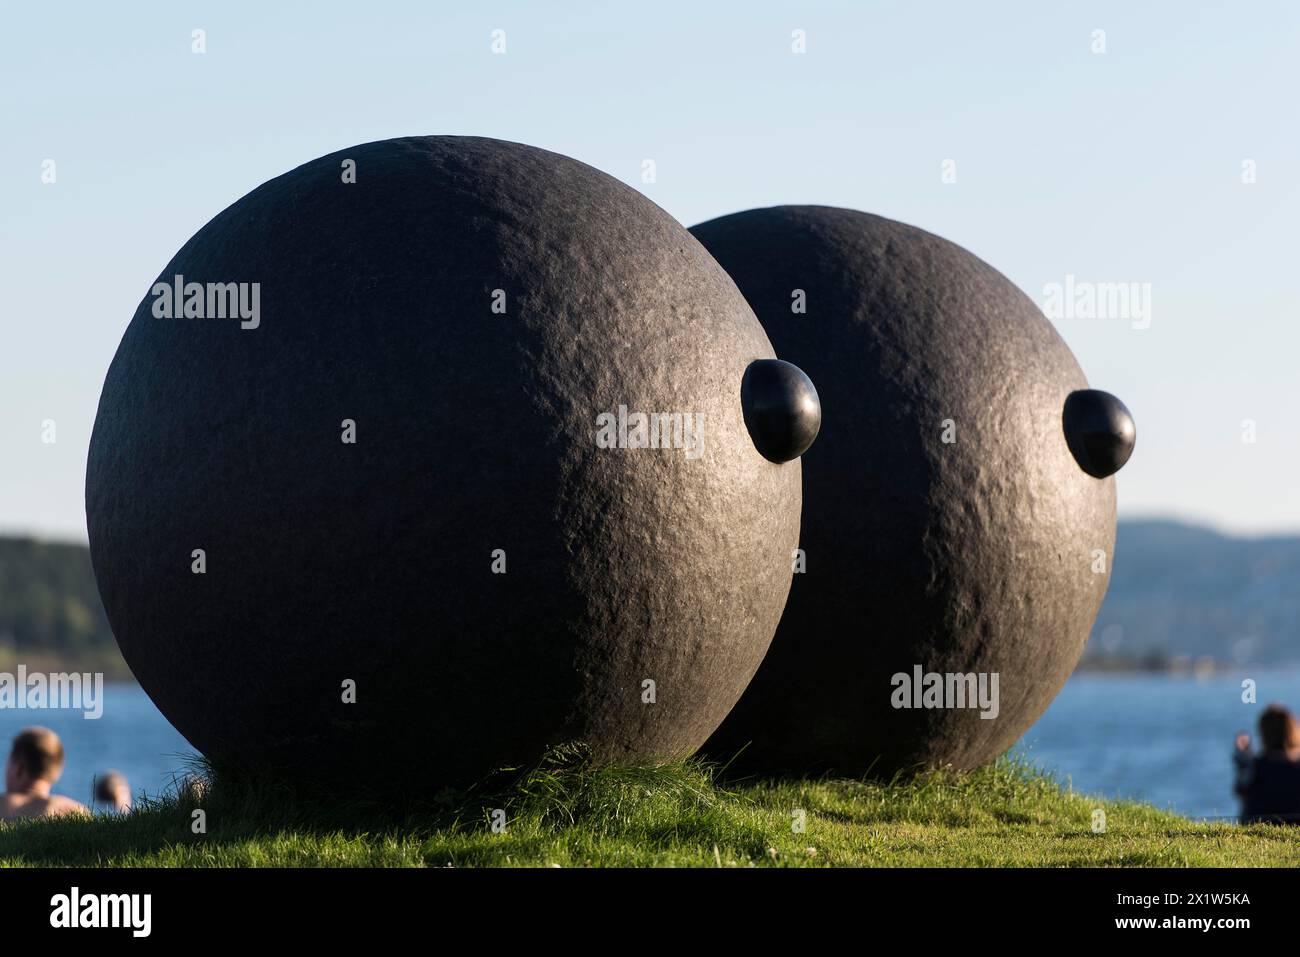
<box><xmin>1232</xmin><ymin>705</ymin><xmax>1300</xmax><ymax>824</ymax></box>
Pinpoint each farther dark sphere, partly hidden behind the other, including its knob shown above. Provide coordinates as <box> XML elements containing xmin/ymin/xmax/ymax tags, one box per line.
<box><xmin>692</xmin><ymin>207</ymin><xmax>1134</xmax><ymax>775</ymax></box>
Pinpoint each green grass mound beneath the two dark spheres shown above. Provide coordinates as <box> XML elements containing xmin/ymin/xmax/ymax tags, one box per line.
<box><xmin>0</xmin><ymin>759</ymin><xmax>1300</xmax><ymax>867</ymax></box>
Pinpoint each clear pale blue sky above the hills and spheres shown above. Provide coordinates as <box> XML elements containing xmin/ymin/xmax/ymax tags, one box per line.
<box><xmin>0</xmin><ymin>0</ymin><xmax>1300</xmax><ymax>538</ymax></box>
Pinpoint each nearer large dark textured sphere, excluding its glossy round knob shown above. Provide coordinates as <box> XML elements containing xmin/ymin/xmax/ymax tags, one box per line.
<box><xmin>86</xmin><ymin>137</ymin><xmax>800</xmax><ymax>789</ymax></box>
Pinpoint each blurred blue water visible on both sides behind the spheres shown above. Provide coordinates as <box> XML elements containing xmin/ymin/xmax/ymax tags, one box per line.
<box><xmin>0</xmin><ymin>671</ymin><xmax>1300</xmax><ymax>817</ymax></box>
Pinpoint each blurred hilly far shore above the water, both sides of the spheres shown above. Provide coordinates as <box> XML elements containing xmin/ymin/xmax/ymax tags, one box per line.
<box><xmin>0</xmin><ymin>521</ymin><xmax>1300</xmax><ymax>677</ymax></box>
